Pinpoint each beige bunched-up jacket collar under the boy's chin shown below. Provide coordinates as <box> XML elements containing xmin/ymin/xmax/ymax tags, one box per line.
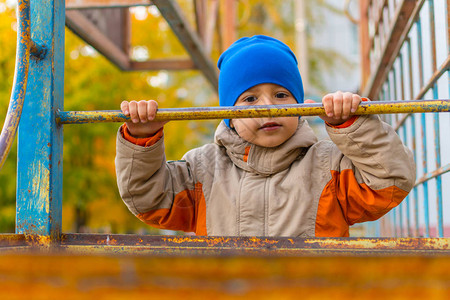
<box><xmin>215</xmin><ymin>119</ymin><xmax>317</xmax><ymax>176</ymax></box>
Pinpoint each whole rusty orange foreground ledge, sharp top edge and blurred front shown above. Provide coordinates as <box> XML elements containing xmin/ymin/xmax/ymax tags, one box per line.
<box><xmin>0</xmin><ymin>234</ymin><xmax>450</xmax><ymax>300</ymax></box>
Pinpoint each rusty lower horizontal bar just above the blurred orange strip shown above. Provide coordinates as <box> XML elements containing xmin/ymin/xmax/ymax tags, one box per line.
<box><xmin>0</xmin><ymin>233</ymin><xmax>450</xmax><ymax>256</ymax></box>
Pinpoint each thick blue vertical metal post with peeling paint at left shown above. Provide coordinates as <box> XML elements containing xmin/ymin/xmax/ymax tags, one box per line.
<box><xmin>16</xmin><ymin>0</ymin><xmax>65</xmax><ymax>240</ymax></box>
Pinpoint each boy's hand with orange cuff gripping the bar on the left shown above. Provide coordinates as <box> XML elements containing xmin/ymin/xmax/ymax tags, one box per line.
<box><xmin>120</xmin><ymin>100</ymin><xmax>168</xmax><ymax>138</ymax></box>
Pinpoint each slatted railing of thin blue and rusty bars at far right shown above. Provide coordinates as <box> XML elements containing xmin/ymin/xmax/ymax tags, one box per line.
<box><xmin>361</xmin><ymin>0</ymin><xmax>450</xmax><ymax>237</ymax></box>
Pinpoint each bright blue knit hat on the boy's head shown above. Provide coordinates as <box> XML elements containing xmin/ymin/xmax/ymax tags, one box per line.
<box><xmin>217</xmin><ymin>35</ymin><xmax>304</xmax><ymax>127</ymax></box>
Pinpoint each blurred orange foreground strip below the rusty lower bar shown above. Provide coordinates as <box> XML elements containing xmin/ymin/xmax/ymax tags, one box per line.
<box><xmin>0</xmin><ymin>253</ymin><xmax>450</xmax><ymax>300</ymax></box>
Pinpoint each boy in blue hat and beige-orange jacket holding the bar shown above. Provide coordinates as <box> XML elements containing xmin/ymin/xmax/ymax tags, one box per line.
<box><xmin>116</xmin><ymin>36</ymin><xmax>415</xmax><ymax>237</ymax></box>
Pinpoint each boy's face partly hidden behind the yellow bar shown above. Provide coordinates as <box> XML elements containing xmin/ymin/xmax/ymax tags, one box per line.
<box><xmin>230</xmin><ymin>83</ymin><xmax>298</xmax><ymax>147</ymax></box>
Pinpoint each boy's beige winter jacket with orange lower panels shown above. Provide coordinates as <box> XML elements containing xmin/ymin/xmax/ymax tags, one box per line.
<box><xmin>116</xmin><ymin>116</ymin><xmax>415</xmax><ymax>237</ymax></box>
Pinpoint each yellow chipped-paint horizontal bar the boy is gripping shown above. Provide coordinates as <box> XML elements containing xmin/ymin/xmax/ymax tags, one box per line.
<box><xmin>57</xmin><ymin>100</ymin><xmax>450</xmax><ymax>124</ymax></box>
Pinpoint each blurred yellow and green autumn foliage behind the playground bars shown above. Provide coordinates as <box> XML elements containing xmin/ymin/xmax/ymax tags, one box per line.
<box><xmin>0</xmin><ymin>0</ymin><xmax>352</xmax><ymax>233</ymax></box>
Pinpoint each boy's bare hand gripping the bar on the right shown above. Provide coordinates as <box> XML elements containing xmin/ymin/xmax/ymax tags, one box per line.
<box><xmin>305</xmin><ymin>91</ymin><xmax>361</xmax><ymax>125</ymax></box>
